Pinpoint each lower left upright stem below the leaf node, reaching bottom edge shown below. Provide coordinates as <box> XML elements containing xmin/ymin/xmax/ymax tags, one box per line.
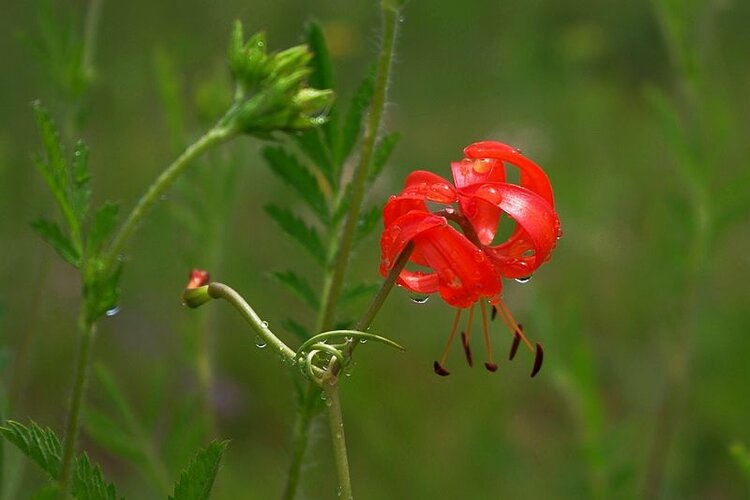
<box><xmin>60</xmin><ymin>314</ymin><xmax>96</xmax><ymax>498</ymax></box>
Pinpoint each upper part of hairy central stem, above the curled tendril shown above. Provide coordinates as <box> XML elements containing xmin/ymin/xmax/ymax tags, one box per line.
<box><xmin>315</xmin><ymin>1</ymin><xmax>399</xmax><ymax>333</ymax></box>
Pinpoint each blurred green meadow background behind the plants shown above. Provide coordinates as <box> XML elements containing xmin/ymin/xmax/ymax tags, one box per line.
<box><xmin>0</xmin><ymin>0</ymin><xmax>750</xmax><ymax>499</ymax></box>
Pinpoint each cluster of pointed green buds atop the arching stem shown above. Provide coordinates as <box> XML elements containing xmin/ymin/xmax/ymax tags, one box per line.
<box><xmin>223</xmin><ymin>21</ymin><xmax>333</xmax><ymax>136</ymax></box>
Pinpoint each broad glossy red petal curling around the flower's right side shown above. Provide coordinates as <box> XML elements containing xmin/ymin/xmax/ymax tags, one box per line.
<box><xmin>465</xmin><ymin>183</ymin><xmax>560</xmax><ymax>277</ymax></box>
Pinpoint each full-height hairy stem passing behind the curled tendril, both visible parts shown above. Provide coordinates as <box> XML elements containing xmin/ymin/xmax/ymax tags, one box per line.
<box><xmin>283</xmin><ymin>2</ymin><xmax>399</xmax><ymax>500</ymax></box>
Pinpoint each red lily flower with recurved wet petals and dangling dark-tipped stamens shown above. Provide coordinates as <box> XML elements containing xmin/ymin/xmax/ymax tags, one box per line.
<box><xmin>380</xmin><ymin>141</ymin><xmax>560</xmax><ymax>376</ymax></box>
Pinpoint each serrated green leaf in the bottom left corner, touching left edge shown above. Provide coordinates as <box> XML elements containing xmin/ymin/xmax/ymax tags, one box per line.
<box><xmin>0</xmin><ymin>420</ymin><xmax>62</xmax><ymax>479</ymax></box>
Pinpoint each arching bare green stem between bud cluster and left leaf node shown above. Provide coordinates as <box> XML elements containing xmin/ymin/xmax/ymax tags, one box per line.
<box><xmin>104</xmin><ymin>125</ymin><xmax>236</xmax><ymax>271</ymax></box>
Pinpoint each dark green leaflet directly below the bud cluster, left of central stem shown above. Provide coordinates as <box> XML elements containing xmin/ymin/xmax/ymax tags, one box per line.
<box><xmin>262</xmin><ymin>147</ymin><xmax>330</xmax><ymax>223</ymax></box>
